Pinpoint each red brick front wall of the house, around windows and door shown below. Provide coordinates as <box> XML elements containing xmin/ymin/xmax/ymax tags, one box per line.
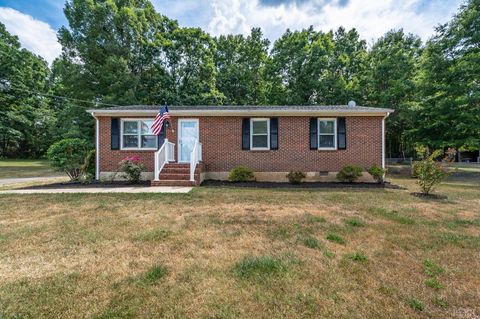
<box><xmin>100</xmin><ymin>117</ymin><xmax>382</xmax><ymax>172</ymax></box>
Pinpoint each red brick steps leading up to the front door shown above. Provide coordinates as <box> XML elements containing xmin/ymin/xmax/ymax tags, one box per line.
<box><xmin>151</xmin><ymin>163</ymin><xmax>204</xmax><ymax>186</ymax></box>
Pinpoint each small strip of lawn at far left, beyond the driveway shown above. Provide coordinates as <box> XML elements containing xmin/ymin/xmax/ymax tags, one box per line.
<box><xmin>0</xmin><ymin>159</ymin><xmax>61</xmax><ymax>178</ymax></box>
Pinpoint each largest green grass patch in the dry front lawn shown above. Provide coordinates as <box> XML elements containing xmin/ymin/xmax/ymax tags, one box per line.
<box><xmin>233</xmin><ymin>255</ymin><xmax>288</xmax><ymax>278</ymax></box>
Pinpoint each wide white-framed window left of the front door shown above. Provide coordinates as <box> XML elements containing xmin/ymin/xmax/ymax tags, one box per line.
<box><xmin>121</xmin><ymin>119</ymin><xmax>157</xmax><ymax>150</ymax></box>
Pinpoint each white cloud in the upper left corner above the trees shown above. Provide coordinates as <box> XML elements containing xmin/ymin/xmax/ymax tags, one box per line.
<box><xmin>0</xmin><ymin>7</ymin><xmax>62</xmax><ymax>64</ymax></box>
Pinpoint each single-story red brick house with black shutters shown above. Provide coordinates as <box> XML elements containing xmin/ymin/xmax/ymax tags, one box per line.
<box><xmin>88</xmin><ymin>105</ymin><xmax>393</xmax><ymax>185</ymax></box>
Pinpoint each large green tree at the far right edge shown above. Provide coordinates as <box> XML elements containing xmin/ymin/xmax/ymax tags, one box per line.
<box><xmin>411</xmin><ymin>0</ymin><xmax>480</xmax><ymax>150</ymax></box>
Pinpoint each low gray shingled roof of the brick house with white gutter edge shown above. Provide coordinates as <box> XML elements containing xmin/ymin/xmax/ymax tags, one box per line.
<box><xmin>91</xmin><ymin>105</ymin><xmax>393</xmax><ymax>112</ymax></box>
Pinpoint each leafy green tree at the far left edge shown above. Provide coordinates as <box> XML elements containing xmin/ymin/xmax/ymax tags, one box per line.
<box><xmin>0</xmin><ymin>23</ymin><xmax>54</xmax><ymax>157</ymax></box>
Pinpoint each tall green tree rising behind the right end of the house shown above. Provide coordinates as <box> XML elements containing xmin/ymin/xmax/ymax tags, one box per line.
<box><xmin>362</xmin><ymin>29</ymin><xmax>422</xmax><ymax>157</ymax></box>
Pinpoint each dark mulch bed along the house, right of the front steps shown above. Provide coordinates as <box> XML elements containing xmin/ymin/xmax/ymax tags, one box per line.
<box><xmin>202</xmin><ymin>180</ymin><xmax>403</xmax><ymax>189</ymax></box>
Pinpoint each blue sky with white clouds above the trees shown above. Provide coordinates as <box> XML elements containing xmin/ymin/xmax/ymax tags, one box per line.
<box><xmin>0</xmin><ymin>0</ymin><xmax>463</xmax><ymax>63</ymax></box>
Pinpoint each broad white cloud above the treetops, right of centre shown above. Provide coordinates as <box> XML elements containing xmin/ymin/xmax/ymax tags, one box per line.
<box><xmin>207</xmin><ymin>0</ymin><xmax>462</xmax><ymax>40</ymax></box>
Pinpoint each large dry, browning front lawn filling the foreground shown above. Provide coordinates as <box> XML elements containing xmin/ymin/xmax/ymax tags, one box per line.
<box><xmin>0</xmin><ymin>178</ymin><xmax>480</xmax><ymax>318</ymax></box>
